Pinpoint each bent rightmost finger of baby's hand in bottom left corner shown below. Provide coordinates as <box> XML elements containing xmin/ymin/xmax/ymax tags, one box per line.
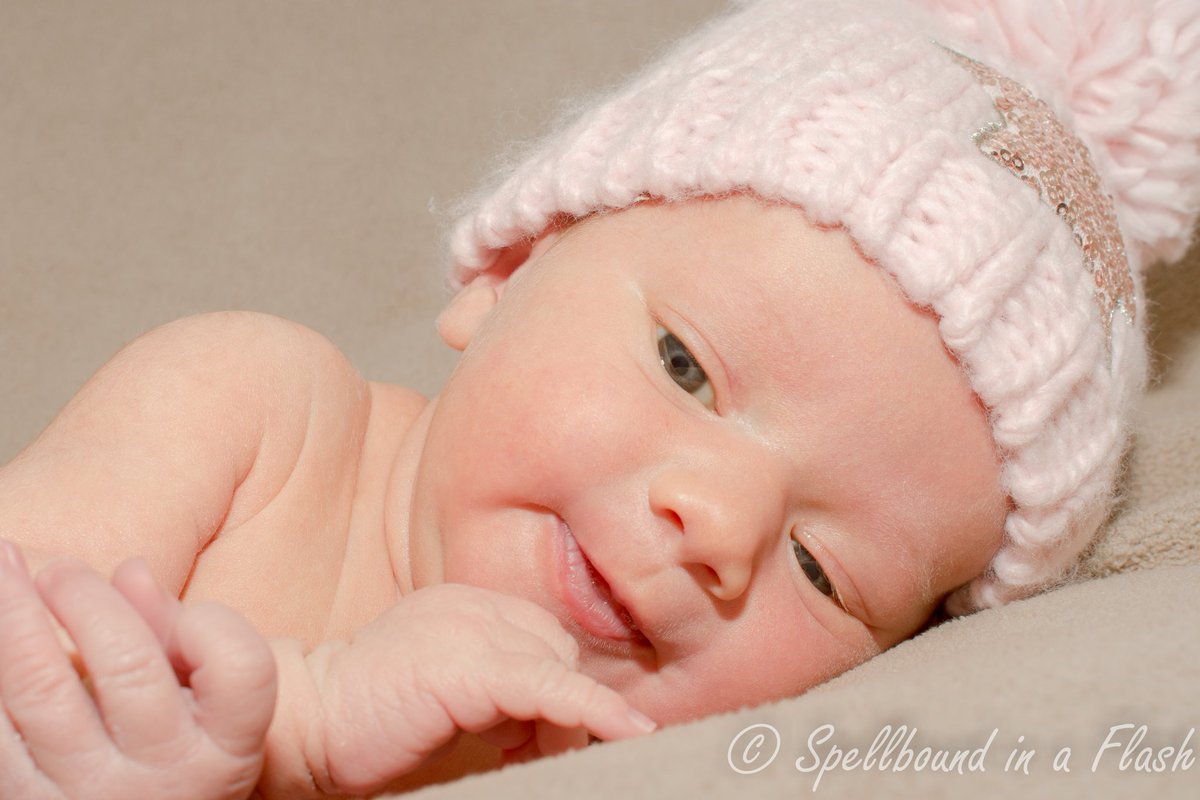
<box><xmin>169</xmin><ymin>603</ymin><xmax>276</xmax><ymax>757</ymax></box>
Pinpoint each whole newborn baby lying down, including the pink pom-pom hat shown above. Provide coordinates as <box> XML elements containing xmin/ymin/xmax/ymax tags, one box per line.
<box><xmin>0</xmin><ymin>0</ymin><xmax>1200</xmax><ymax>798</ymax></box>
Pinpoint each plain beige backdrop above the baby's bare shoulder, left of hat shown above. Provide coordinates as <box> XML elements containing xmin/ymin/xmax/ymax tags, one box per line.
<box><xmin>0</xmin><ymin>0</ymin><xmax>719</xmax><ymax>463</ymax></box>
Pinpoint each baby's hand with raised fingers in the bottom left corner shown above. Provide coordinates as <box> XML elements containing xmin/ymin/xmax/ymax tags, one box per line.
<box><xmin>0</xmin><ymin>542</ymin><xmax>275</xmax><ymax>800</ymax></box>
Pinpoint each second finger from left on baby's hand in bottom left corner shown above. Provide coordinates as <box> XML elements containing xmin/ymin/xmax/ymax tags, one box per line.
<box><xmin>37</xmin><ymin>561</ymin><xmax>191</xmax><ymax>760</ymax></box>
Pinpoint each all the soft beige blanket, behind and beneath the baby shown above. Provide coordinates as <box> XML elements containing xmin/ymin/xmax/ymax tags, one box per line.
<box><xmin>0</xmin><ymin>0</ymin><xmax>1200</xmax><ymax>800</ymax></box>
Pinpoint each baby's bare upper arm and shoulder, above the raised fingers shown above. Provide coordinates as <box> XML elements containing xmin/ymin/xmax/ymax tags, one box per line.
<box><xmin>0</xmin><ymin>312</ymin><xmax>366</xmax><ymax>596</ymax></box>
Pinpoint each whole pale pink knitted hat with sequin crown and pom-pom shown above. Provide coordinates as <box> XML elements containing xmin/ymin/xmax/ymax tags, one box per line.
<box><xmin>452</xmin><ymin>0</ymin><xmax>1200</xmax><ymax>613</ymax></box>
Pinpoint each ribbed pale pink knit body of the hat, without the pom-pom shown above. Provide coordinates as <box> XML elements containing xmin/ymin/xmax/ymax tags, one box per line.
<box><xmin>452</xmin><ymin>0</ymin><xmax>1200</xmax><ymax>613</ymax></box>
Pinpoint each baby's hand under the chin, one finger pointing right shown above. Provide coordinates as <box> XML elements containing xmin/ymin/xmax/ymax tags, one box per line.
<box><xmin>285</xmin><ymin>584</ymin><xmax>654</xmax><ymax>793</ymax></box>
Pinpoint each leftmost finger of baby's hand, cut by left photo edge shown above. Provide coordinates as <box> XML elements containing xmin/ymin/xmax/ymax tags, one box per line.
<box><xmin>0</xmin><ymin>542</ymin><xmax>110</xmax><ymax>771</ymax></box>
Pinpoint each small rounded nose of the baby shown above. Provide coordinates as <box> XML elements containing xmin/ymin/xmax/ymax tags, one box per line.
<box><xmin>649</xmin><ymin>455</ymin><xmax>784</xmax><ymax>600</ymax></box>
